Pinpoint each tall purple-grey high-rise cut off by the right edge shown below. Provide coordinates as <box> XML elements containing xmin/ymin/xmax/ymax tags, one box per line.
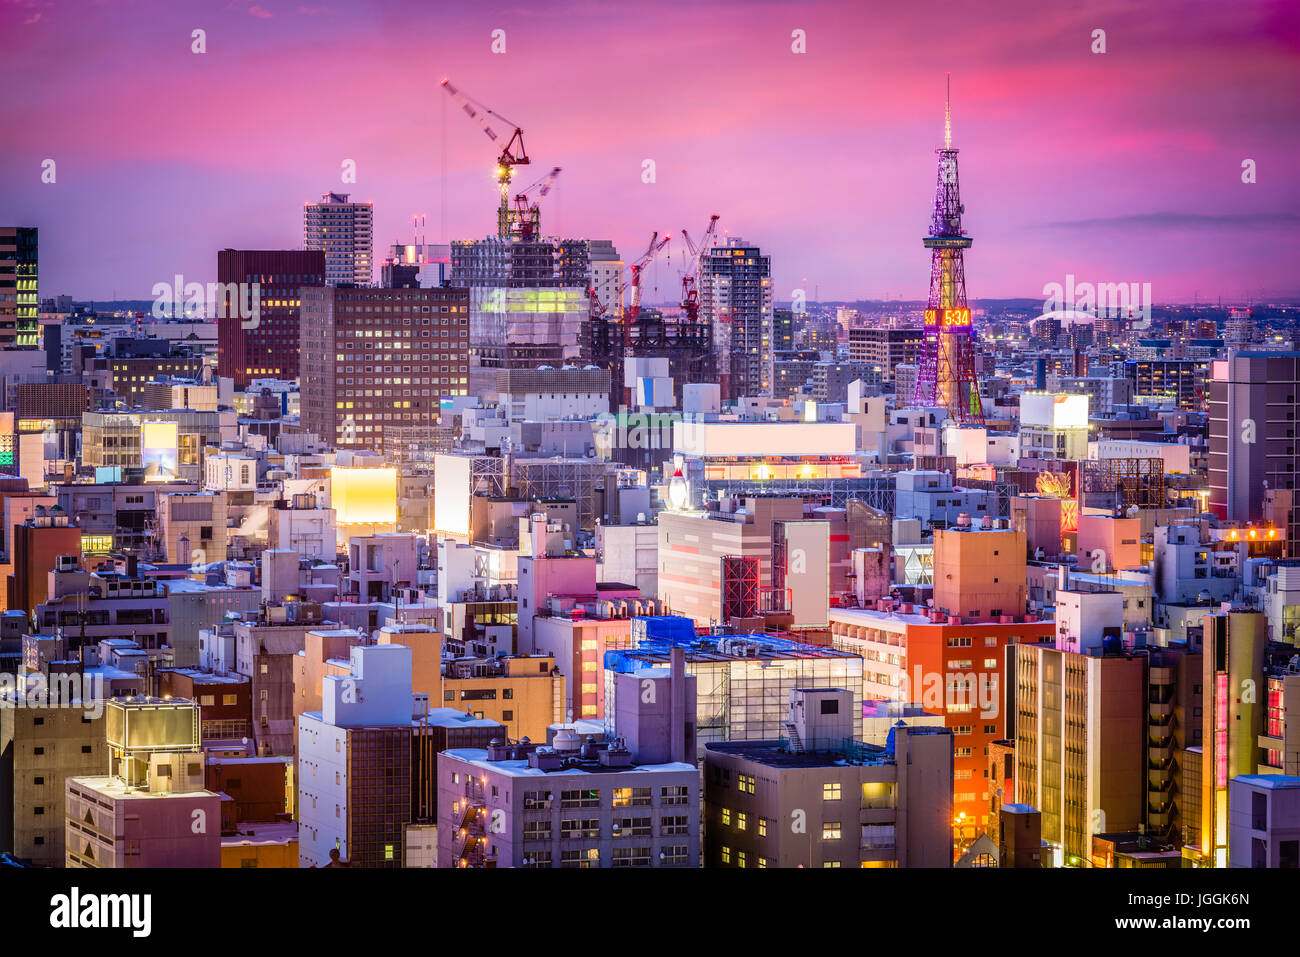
<box><xmin>1209</xmin><ymin>351</ymin><xmax>1300</xmax><ymax>521</ymax></box>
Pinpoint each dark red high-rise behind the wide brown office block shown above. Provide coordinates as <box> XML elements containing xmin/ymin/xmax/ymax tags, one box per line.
<box><xmin>217</xmin><ymin>250</ymin><xmax>325</xmax><ymax>387</ymax></box>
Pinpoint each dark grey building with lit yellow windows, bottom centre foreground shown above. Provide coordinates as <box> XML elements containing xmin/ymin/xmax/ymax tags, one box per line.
<box><xmin>703</xmin><ymin>688</ymin><xmax>953</xmax><ymax>867</ymax></box>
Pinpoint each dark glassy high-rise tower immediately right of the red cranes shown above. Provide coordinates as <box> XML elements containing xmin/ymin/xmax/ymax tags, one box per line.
<box><xmin>698</xmin><ymin>237</ymin><xmax>774</xmax><ymax>398</ymax></box>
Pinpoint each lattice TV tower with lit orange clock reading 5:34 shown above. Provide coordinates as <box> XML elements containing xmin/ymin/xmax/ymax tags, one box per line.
<box><xmin>915</xmin><ymin>77</ymin><xmax>984</xmax><ymax>425</ymax></box>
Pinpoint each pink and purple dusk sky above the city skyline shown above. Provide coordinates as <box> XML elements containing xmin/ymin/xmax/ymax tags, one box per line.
<box><xmin>0</xmin><ymin>0</ymin><xmax>1300</xmax><ymax>302</ymax></box>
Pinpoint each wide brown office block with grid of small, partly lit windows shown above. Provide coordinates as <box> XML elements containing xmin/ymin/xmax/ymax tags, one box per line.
<box><xmin>300</xmin><ymin>286</ymin><xmax>469</xmax><ymax>450</ymax></box>
